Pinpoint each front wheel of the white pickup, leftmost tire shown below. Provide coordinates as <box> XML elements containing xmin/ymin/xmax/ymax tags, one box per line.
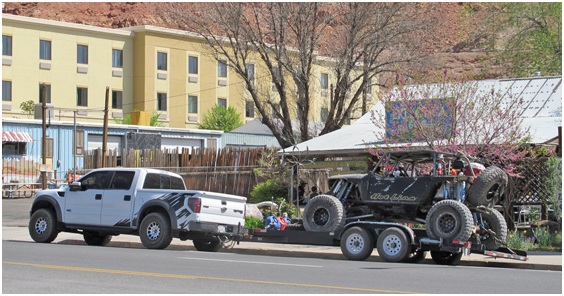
<box><xmin>28</xmin><ymin>209</ymin><xmax>59</xmax><ymax>243</ymax></box>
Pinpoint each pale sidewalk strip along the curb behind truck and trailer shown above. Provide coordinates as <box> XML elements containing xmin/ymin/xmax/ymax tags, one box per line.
<box><xmin>2</xmin><ymin>226</ymin><xmax>562</xmax><ymax>271</ymax></box>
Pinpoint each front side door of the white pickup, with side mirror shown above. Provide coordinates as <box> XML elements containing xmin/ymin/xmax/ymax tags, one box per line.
<box><xmin>63</xmin><ymin>171</ymin><xmax>114</xmax><ymax>225</ymax></box>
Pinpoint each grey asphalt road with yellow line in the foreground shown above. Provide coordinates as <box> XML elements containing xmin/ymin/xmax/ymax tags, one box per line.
<box><xmin>2</xmin><ymin>240</ymin><xmax>562</xmax><ymax>294</ymax></box>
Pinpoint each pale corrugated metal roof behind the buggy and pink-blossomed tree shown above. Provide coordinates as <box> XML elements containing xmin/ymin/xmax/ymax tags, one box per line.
<box><xmin>280</xmin><ymin>76</ymin><xmax>562</xmax><ymax>156</ymax></box>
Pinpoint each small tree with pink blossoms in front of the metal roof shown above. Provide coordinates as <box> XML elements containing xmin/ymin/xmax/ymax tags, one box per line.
<box><xmin>372</xmin><ymin>71</ymin><xmax>529</xmax><ymax>174</ymax></box>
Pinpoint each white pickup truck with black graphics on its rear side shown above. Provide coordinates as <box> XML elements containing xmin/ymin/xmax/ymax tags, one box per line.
<box><xmin>29</xmin><ymin>168</ymin><xmax>246</xmax><ymax>252</ymax></box>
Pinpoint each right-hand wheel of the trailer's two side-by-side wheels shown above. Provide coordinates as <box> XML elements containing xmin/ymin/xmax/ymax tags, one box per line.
<box><xmin>376</xmin><ymin>227</ymin><xmax>411</xmax><ymax>262</ymax></box>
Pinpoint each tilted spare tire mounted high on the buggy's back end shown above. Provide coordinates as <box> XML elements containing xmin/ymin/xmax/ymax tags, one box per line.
<box><xmin>466</xmin><ymin>166</ymin><xmax>508</xmax><ymax>207</ymax></box>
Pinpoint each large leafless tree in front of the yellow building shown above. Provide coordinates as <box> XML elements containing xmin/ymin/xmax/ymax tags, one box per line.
<box><xmin>161</xmin><ymin>2</ymin><xmax>432</xmax><ymax>147</ymax></box>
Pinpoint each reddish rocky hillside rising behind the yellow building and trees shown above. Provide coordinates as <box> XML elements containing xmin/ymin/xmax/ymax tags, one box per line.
<box><xmin>2</xmin><ymin>2</ymin><xmax>497</xmax><ymax>78</ymax></box>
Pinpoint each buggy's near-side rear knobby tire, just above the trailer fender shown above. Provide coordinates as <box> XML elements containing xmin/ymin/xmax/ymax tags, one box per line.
<box><xmin>425</xmin><ymin>200</ymin><xmax>474</xmax><ymax>241</ymax></box>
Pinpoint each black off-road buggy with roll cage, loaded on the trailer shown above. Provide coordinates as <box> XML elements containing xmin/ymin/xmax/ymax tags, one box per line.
<box><xmin>303</xmin><ymin>150</ymin><xmax>507</xmax><ymax>250</ymax></box>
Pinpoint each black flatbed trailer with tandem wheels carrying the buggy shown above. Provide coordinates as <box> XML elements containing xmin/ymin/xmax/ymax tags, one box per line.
<box><xmin>242</xmin><ymin>221</ymin><xmax>527</xmax><ymax>265</ymax></box>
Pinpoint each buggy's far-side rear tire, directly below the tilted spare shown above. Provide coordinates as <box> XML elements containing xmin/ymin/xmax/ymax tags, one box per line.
<box><xmin>470</xmin><ymin>209</ymin><xmax>507</xmax><ymax>251</ymax></box>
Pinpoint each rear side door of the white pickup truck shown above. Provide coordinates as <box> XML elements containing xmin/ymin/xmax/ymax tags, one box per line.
<box><xmin>101</xmin><ymin>171</ymin><xmax>135</xmax><ymax>227</ymax></box>
